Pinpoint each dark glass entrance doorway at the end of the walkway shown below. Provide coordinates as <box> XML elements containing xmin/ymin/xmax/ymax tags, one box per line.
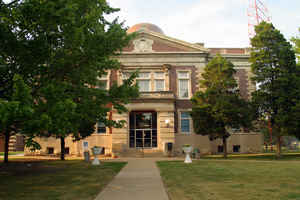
<box><xmin>129</xmin><ymin>111</ymin><xmax>157</xmax><ymax>148</ymax></box>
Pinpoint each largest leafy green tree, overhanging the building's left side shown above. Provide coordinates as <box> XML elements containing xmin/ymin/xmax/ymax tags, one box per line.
<box><xmin>0</xmin><ymin>0</ymin><xmax>138</xmax><ymax>160</ymax></box>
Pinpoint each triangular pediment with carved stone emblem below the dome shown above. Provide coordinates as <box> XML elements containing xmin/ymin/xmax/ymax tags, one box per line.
<box><xmin>123</xmin><ymin>31</ymin><xmax>209</xmax><ymax>53</ymax></box>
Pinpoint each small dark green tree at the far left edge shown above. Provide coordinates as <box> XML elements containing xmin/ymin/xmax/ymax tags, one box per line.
<box><xmin>0</xmin><ymin>75</ymin><xmax>34</xmax><ymax>163</ymax></box>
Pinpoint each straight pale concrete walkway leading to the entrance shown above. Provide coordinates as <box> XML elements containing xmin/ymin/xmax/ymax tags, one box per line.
<box><xmin>95</xmin><ymin>158</ymin><xmax>169</xmax><ymax>200</ymax></box>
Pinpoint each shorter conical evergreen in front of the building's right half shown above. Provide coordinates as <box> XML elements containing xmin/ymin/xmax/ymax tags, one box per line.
<box><xmin>191</xmin><ymin>55</ymin><xmax>252</xmax><ymax>158</ymax></box>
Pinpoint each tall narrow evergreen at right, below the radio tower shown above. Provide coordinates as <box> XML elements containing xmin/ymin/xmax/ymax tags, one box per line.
<box><xmin>250</xmin><ymin>22</ymin><xmax>300</xmax><ymax>158</ymax></box>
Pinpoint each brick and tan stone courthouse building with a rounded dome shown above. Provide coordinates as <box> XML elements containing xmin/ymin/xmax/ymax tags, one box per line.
<box><xmin>27</xmin><ymin>23</ymin><xmax>262</xmax><ymax>156</ymax></box>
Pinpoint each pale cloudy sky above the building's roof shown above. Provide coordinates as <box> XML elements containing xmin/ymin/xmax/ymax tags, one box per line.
<box><xmin>108</xmin><ymin>0</ymin><xmax>300</xmax><ymax>47</ymax></box>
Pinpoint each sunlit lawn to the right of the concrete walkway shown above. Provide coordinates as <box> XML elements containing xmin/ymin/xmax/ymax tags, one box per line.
<box><xmin>158</xmin><ymin>160</ymin><xmax>300</xmax><ymax>200</ymax></box>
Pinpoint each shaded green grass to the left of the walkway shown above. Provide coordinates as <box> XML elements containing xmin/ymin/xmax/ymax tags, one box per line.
<box><xmin>0</xmin><ymin>161</ymin><xmax>126</xmax><ymax>200</ymax></box>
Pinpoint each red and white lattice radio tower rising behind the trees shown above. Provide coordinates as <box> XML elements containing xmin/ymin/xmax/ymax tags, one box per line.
<box><xmin>248</xmin><ymin>0</ymin><xmax>271</xmax><ymax>39</ymax></box>
